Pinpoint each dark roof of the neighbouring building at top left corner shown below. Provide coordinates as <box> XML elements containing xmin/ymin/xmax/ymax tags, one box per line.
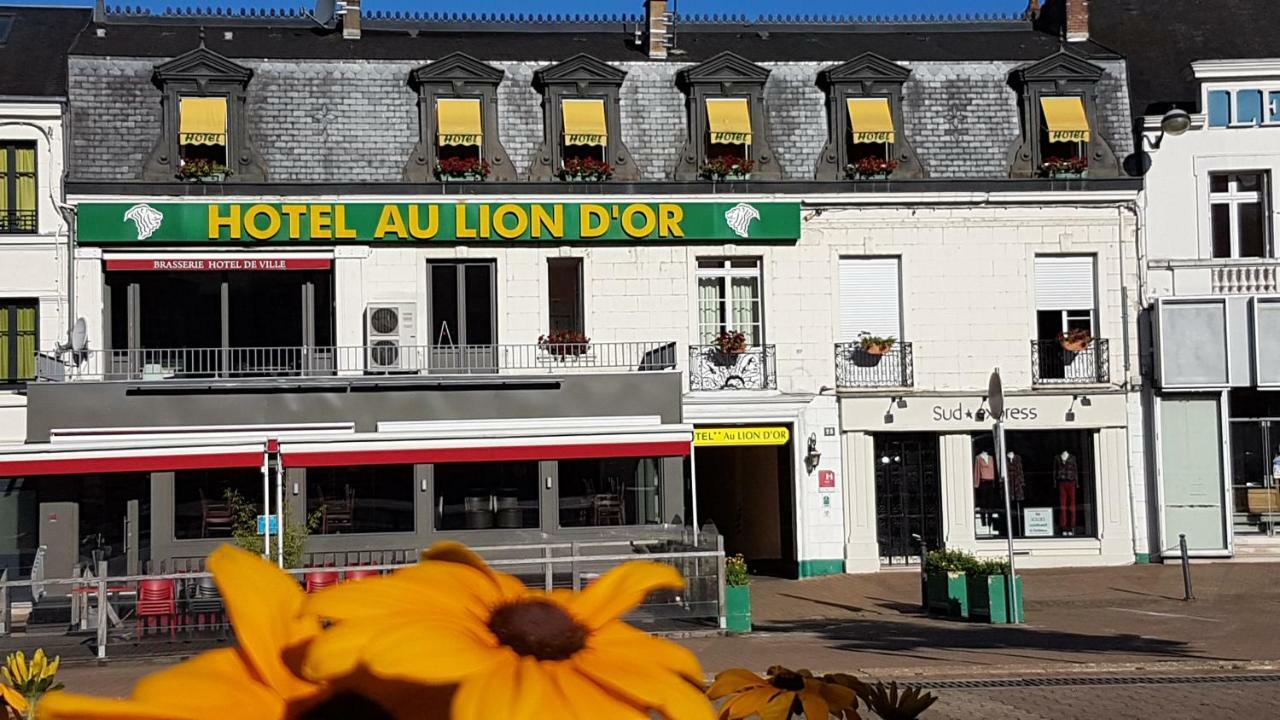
<box><xmin>0</xmin><ymin>5</ymin><xmax>92</xmax><ymax>97</ymax></box>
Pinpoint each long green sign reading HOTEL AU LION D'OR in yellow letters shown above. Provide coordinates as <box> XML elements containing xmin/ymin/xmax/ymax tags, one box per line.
<box><xmin>77</xmin><ymin>201</ymin><xmax>800</xmax><ymax>245</ymax></box>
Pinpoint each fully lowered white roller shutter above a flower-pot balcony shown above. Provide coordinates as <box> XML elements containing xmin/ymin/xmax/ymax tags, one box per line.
<box><xmin>840</xmin><ymin>258</ymin><xmax>902</xmax><ymax>342</ymax></box>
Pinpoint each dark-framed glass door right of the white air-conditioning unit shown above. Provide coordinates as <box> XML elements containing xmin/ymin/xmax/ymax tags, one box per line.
<box><xmin>425</xmin><ymin>263</ymin><xmax>498</xmax><ymax>373</ymax></box>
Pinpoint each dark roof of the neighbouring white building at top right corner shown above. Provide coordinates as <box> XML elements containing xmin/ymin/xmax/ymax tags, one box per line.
<box><xmin>1089</xmin><ymin>0</ymin><xmax>1280</xmax><ymax>117</ymax></box>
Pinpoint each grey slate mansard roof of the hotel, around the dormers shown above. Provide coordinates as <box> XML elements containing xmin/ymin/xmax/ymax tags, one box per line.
<box><xmin>69</xmin><ymin>11</ymin><xmax>1132</xmax><ymax>183</ymax></box>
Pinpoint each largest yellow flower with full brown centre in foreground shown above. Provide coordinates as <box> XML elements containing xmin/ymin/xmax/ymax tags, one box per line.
<box><xmin>303</xmin><ymin>543</ymin><xmax>714</xmax><ymax>720</ymax></box>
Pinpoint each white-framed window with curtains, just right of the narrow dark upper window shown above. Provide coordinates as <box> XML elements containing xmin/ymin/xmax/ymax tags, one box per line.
<box><xmin>698</xmin><ymin>258</ymin><xmax>764</xmax><ymax>347</ymax></box>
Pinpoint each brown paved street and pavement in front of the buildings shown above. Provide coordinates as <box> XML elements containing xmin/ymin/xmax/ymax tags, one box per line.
<box><xmin>22</xmin><ymin>562</ymin><xmax>1280</xmax><ymax>720</ymax></box>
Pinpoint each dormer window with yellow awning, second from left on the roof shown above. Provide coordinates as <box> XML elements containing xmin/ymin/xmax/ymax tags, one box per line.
<box><xmin>403</xmin><ymin>53</ymin><xmax>516</xmax><ymax>182</ymax></box>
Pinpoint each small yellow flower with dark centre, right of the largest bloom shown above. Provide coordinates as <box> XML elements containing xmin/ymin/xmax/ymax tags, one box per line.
<box><xmin>707</xmin><ymin>666</ymin><xmax>858</xmax><ymax>720</ymax></box>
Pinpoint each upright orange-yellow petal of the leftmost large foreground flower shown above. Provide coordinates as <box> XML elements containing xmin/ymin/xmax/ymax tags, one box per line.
<box><xmin>209</xmin><ymin>544</ymin><xmax>319</xmax><ymax>698</ymax></box>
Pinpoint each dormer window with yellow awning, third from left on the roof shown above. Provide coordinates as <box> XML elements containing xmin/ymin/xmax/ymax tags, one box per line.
<box><xmin>529</xmin><ymin>55</ymin><xmax>640</xmax><ymax>182</ymax></box>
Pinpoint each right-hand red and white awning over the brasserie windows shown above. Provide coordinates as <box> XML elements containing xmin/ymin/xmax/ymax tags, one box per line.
<box><xmin>280</xmin><ymin>418</ymin><xmax>694</xmax><ymax>468</ymax></box>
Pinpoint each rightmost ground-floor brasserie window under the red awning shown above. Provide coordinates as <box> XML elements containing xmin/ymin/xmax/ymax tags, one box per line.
<box><xmin>559</xmin><ymin>457</ymin><xmax>662</xmax><ymax>528</ymax></box>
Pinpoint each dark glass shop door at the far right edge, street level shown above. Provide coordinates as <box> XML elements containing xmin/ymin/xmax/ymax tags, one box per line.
<box><xmin>1231</xmin><ymin>418</ymin><xmax>1280</xmax><ymax>538</ymax></box>
